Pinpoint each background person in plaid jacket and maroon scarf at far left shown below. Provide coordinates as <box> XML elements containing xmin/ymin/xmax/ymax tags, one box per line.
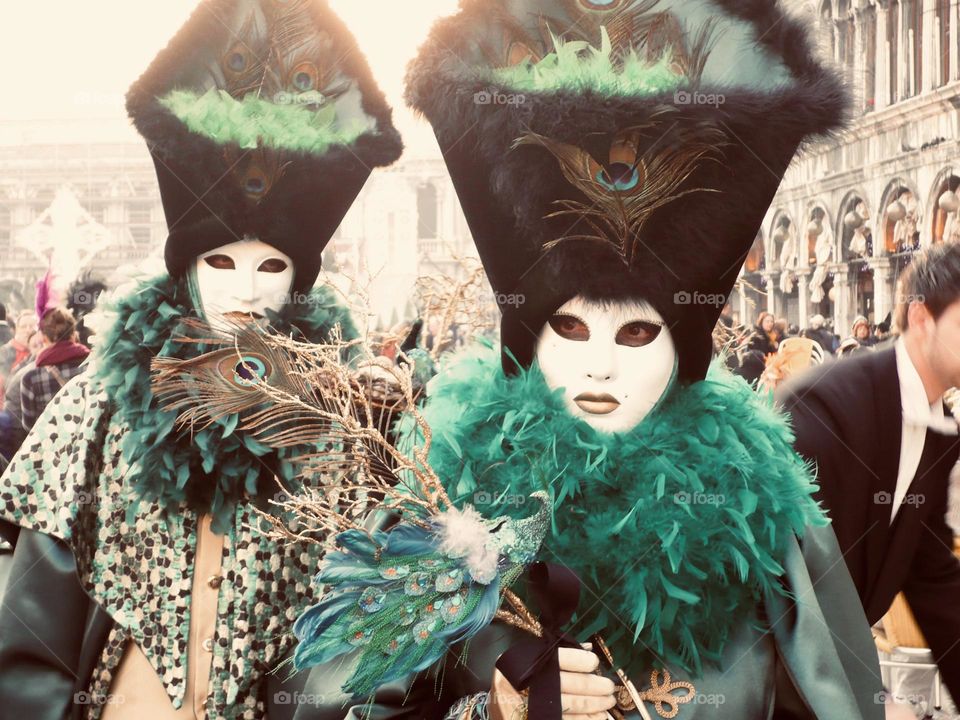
<box><xmin>20</xmin><ymin>307</ymin><xmax>90</xmax><ymax>430</ymax></box>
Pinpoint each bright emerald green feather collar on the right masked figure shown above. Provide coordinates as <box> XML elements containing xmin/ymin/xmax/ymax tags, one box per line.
<box><xmin>416</xmin><ymin>345</ymin><xmax>827</xmax><ymax>675</ymax></box>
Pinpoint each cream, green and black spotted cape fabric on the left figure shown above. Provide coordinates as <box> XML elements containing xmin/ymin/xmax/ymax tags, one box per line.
<box><xmin>0</xmin><ymin>375</ymin><xmax>322</xmax><ymax>720</ymax></box>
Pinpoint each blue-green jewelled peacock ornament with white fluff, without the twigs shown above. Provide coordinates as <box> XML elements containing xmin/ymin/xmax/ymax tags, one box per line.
<box><xmin>294</xmin><ymin>493</ymin><xmax>549</xmax><ymax>697</ymax></box>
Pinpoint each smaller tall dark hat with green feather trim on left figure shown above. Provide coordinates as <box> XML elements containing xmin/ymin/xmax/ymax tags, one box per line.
<box><xmin>127</xmin><ymin>0</ymin><xmax>402</xmax><ymax>290</ymax></box>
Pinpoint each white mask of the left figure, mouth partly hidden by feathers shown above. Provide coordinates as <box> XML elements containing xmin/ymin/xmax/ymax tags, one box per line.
<box><xmin>196</xmin><ymin>240</ymin><xmax>294</xmax><ymax>319</ymax></box>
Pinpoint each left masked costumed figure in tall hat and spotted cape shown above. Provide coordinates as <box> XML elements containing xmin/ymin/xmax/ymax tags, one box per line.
<box><xmin>0</xmin><ymin>0</ymin><xmax>402</xmax><ymax>720</ymax></box>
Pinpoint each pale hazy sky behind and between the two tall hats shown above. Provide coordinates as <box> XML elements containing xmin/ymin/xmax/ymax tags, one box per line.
<box><xmin>0</xmin><ymin>0</ymin><xmax>457</xmax><ymax>155</ymax></box>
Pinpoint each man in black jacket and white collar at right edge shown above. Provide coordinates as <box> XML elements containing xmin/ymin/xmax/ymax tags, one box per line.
<box><xmin>777</xmin><ymin>245</ymin><xmax>960</xmax><ymax>698</ymax></box>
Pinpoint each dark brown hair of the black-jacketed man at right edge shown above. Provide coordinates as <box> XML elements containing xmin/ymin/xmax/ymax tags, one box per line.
<box><xmin>894</xmin><ymin>243</ymin><xmax>960</xmax><ymax>333</ymax></box>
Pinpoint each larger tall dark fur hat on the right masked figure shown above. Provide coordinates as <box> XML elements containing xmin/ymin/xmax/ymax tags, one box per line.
<box><xmin>407</xmin><ymin>0</ymin><xmax>848</xmax><ymax>381</ymax></box>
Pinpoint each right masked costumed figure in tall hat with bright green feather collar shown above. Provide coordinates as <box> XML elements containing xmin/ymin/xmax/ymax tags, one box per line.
<box><xmin>310</xmin><ymin>0</ymin><xmax>883</xmax><ymax>720</ymax></box>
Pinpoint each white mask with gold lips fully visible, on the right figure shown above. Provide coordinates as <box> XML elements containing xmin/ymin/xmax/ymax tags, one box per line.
<box><xmin>537</xmin><ymin>296</ymin><xmax>677</xmax><ymax>433</ymax></box>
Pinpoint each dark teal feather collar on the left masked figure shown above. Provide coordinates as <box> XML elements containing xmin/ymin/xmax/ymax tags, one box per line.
<box><xmin>87</xmin><ymin>275</ymin><xmax>356</xmax><ymax>532</ymax></box>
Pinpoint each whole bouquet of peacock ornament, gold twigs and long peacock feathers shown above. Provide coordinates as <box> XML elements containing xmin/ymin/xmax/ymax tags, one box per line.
<box><xmin>153</xmin><ymin>321</ymin><xmax>549</xmax><ymax>697</ymax></box>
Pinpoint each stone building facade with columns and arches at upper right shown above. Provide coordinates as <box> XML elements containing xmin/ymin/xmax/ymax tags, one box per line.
<box><xmin>732</xmin><ymin>0</ymin><xmax>960</xmax><ymax>336</ymax></box>
